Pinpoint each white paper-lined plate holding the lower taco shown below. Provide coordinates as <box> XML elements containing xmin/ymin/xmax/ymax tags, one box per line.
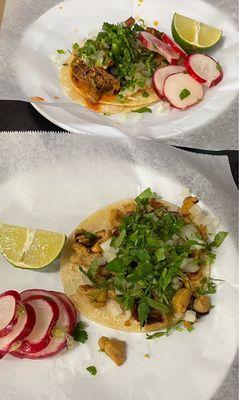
<box><xmin>0</xmin><ymin>132</ymin><xmax>238</xmax><ymax>400</ymax></box>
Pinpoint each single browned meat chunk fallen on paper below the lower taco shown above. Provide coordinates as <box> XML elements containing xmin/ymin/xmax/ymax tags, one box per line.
<box><xmin>98</xmin><ymin>336</ymin><xmax>126</xmax><ymax>366</ymax></box>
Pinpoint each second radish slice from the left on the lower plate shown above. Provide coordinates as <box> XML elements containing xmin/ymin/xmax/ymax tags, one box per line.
<box><xmin>0</xmin><ymin>304</ymin><xmax>36</xmax><ymax>359</ymax></box>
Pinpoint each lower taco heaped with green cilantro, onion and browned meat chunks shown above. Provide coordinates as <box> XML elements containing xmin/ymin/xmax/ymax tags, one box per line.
<box><xmin>60</xmin><ymin>188</ymin><xmax>225</xmax><ymax>332</ymax></box>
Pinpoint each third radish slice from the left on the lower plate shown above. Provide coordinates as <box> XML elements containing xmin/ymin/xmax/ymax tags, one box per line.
<box><xmin>19</xmin><ymin>295</ymin><xmax>59</xmax><ymax>353</ymax></box>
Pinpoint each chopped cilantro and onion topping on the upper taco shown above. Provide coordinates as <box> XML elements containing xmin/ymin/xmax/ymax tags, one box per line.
<box><xmin>73</xmin><ymin>22</ymin><xmax>157</xmax><ymax>96</ymax></box>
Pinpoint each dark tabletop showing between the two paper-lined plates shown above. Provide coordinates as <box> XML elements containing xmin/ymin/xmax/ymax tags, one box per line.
<box><xmin>0</xmin><ymin>100</ymin><xmax>239</xmax><ymax>186</ymax></box>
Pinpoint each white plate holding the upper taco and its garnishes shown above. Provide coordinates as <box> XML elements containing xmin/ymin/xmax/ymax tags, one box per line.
<box><xmin>19</xmin><ymin>0</ymin><xmax>239</xmax><ymax>138</ymax></box>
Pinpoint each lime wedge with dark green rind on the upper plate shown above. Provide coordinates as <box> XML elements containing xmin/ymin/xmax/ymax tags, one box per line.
<box><xmin>172</xmin><ymin>13</ymin><xmax>222</xmax><ymax>53</ymax></box>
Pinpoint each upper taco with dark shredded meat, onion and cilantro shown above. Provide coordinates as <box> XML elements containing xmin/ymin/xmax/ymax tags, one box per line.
<box><xmin>60</xmin><ymin>18</ymin><xmax>168</xmax><ymax>114</ymax></box>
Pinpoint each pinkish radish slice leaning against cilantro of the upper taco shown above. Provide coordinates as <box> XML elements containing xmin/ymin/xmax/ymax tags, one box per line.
<box><xmin>139</xmin><ymin>31</ymin><xmax>180</xmax><ymax>65</ymax></box>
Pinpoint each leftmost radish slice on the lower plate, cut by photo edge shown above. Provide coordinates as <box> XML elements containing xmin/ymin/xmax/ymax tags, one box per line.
<box><xmin>0</xmin><ymin>290</ymin><xmax>21</xmax><ymax>338</ymax></box>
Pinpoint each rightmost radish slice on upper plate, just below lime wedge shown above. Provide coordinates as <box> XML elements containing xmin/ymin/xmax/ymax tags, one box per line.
<box><xmin>185</xmin><ymin>54</ymin><xmax>223</xmax><ymax>87</ymax></box>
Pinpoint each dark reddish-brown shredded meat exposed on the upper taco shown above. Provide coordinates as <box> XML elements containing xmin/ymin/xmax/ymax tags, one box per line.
<box><xmin>71</xmin><ymin>57</ymin><xmax>120</xmax><ymax>103</ymax></box>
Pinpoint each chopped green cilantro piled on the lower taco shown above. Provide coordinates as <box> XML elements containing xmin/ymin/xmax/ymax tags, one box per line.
<box><xmin>79</xmin><ymin>188</ymin><xmax>228</xmax><ymax>326</ymax></box>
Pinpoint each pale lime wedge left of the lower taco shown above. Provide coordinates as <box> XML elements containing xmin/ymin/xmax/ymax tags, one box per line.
<box><xmin>0</xmin><ymin>224</ymin><xmax>66</xmax><ymax>269</ymax></box>
